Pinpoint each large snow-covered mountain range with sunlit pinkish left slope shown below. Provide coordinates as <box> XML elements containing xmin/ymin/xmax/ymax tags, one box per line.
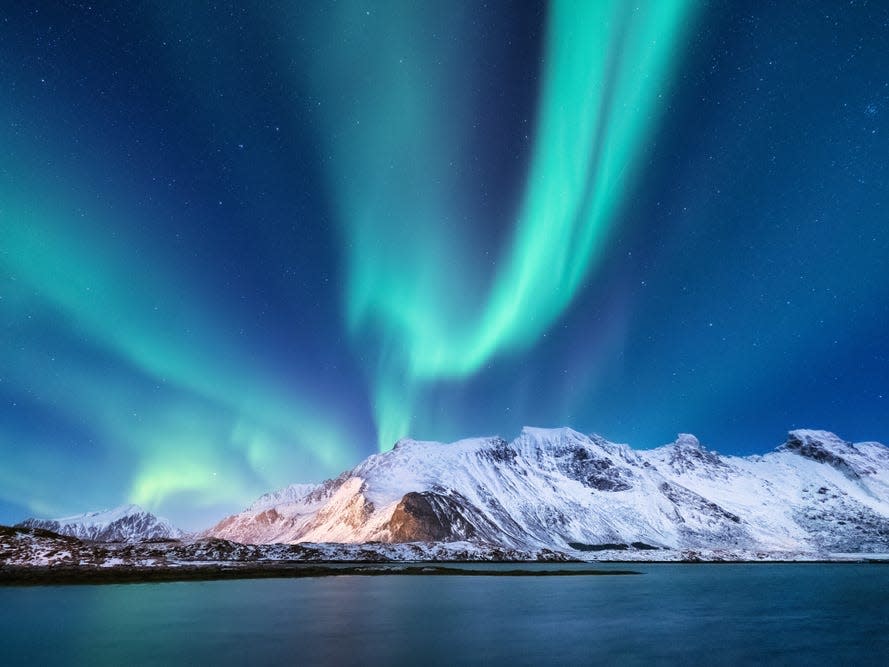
<box><xmin>205</xmin><ymin>428</ymin><xmax>889</xmax><ymax>553</ymax></box>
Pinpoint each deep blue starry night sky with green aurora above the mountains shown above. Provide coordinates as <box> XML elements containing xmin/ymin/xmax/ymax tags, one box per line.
<box><xmin>0</xmin><ymin>0</ymin><xmax>889</xmax><ymax>528</ymax></box>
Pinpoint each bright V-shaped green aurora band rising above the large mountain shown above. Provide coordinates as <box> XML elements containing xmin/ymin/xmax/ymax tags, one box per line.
<box><xmin>294</xmin><ymin>0</ymin><xmax>692</xmax><ymax>449</ymax></box>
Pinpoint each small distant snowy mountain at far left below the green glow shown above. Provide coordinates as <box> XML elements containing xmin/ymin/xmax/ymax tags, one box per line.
<box><xmin>17</xmin><ymin>505</ymin><xmax>185</xmax><ymax>542</ymax></box>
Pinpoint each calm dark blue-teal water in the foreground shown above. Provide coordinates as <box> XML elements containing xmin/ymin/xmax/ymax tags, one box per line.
<box><xmin>0</xmin><ymin>564</ymin><xmax>889</xmax><ymax>665</ymax></box>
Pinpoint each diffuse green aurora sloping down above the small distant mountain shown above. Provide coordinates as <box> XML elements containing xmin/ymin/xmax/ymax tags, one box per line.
<box><xmin>0</xmin><ymin>191</ymin><xmax>355</xmax><ymax>507</ymax></box>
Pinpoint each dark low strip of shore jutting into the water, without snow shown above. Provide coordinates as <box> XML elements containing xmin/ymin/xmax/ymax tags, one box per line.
<box><xmin>0</xmin><ymin>562</ymin><xmax>641</xmax><ymax>586</ymax></box>
